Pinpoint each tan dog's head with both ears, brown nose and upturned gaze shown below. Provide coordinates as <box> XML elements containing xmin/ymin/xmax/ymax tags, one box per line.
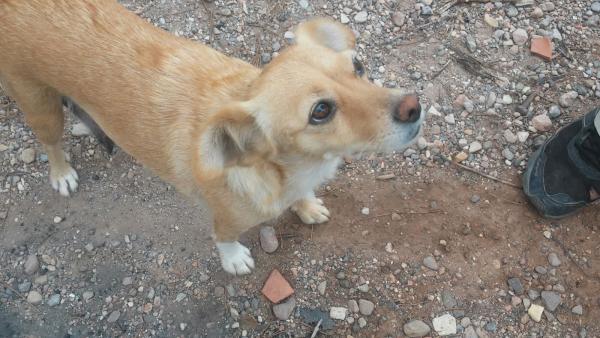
<box><xmin>202</xmin><ymin>19</ymin><xmax>424</xmax><ymax>169</ymax></box>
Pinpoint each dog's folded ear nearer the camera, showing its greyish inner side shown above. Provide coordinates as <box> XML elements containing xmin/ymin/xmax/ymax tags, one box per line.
<box><xmin>200</xmin><ymin>103</ymin><xmax>275</xmax><ymax>169</ymax></box>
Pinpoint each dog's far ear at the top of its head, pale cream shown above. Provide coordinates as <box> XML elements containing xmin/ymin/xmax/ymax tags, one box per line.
<box><xmin>296</xmin><ymin>18</ymin><xmax>356</xmax><ymax>52</ymax></box>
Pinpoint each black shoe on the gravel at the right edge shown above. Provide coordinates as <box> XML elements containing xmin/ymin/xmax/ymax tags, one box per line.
<box><xmin>523</xmin><ymin>108</ymin><xmax>600</xmax><ymax>218</ymax></box>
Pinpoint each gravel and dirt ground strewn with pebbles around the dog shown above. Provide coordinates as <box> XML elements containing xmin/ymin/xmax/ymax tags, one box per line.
<box><xmin>0</xmin><ymin>0</ymin><xmax>600</xmax><ymax>337</ymax></box>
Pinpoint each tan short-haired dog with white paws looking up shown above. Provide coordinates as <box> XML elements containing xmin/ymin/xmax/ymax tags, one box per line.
<box><xmin>0</xmin><ymin>0</ymin><xmax>423</xmax><ymax>274</ymax></box>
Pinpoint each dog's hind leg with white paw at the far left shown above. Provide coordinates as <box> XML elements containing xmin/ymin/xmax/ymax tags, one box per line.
<box><xmin>3</xmin><ymin>78</ymin><xmax>79</xmax><ymax>196</ymax></box>
